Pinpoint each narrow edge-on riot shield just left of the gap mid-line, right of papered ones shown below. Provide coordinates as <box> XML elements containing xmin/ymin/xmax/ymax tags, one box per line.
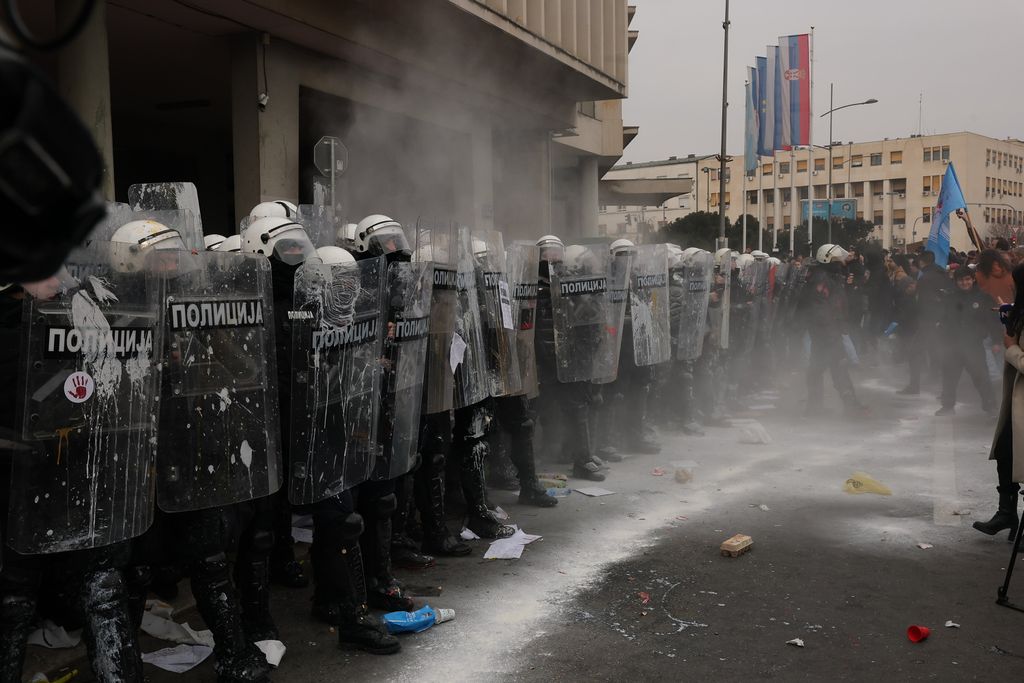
<box><xmin>505</xmin><ymin>241</ymin><xmax>541</xmax><ymax>398</ymax></box>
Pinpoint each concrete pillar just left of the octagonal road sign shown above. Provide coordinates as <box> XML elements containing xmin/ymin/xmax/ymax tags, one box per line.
<box><xmin>231</xmin><ymin>34</ymin><xmax>299</xmax><ymax>222</ymax></box>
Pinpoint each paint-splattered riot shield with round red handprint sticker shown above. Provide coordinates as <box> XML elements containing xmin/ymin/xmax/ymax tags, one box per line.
<box><xmin>6</xmin><ymin>242</ymin><xmax>163</xmax><ymax>554</ymax></box>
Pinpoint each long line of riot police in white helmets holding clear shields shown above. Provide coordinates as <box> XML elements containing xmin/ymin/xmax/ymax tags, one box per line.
<box><xmin>0</xmin><ymin>183</ymin><xmax>741</xmax><ymax>681</ymax></box>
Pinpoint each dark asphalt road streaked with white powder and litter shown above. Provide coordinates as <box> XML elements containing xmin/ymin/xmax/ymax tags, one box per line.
<box><xmin>27</xmin><ymin>360</ymin><xmax>1024</xmax><ymax>682</ymax></box>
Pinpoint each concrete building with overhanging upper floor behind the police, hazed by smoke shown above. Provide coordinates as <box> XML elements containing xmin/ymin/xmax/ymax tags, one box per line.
<box><xmin>12</xmin><ymin>0</ymin><xmax>637</xmax><ymax>244</ymax></box>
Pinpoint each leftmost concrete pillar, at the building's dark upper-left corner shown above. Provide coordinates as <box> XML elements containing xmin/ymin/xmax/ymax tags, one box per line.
<box><xmin>54</xmin><ymin>0</ymin><xmax>114</xmax><ymax>202</ymax></box>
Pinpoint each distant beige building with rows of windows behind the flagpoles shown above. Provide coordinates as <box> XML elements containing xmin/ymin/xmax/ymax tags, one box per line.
<box><xmin>598</xmin><ymin>132</ymin><xmax>1024</xmax><ymax>251</ymax></box>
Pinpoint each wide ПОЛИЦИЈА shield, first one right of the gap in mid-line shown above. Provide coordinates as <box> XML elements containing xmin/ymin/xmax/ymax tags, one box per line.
<box><xmin>551</xmin><ymin>245</ymin><xmax>614</xmax><ymax>382</ymax></box>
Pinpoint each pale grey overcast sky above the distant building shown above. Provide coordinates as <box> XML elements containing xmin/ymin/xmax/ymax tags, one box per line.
<box><xmin>623</xmin><ymin>0</ymin><xmax>1024</xmax><ymax>162</ymax></box>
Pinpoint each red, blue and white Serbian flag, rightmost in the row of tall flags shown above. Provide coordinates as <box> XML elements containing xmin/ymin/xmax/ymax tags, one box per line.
<box><xmin>776</xmin><ymin>33</ymin><xmax>811</xmax><ymax>146</ymax></box>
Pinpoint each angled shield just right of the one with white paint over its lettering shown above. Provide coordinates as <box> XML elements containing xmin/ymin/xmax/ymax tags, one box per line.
<box><xmin>374</xmin><ymin>263</ymin><xmax>434</xmax><ymax>479</ymax></box>
